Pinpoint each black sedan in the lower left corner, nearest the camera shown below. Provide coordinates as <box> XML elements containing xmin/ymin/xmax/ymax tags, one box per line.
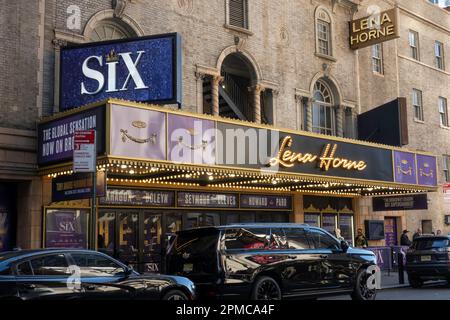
<box><xmin>0</xmin><ymin>249</ymin><xmax>195</xmax><ymax>300</ymax></box>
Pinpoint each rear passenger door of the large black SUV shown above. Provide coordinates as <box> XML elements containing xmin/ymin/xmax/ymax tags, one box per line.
<box><xmin>281</xmin><ymin>228</ymin><xmax>320</xmax><ymax>295</ymax></box>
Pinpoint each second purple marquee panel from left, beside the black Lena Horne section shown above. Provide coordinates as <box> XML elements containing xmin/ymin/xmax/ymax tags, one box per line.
<box><xmin>168</xmin><ymin>114</ymin><xmax>216</xmax><ymax>164</ymax></box>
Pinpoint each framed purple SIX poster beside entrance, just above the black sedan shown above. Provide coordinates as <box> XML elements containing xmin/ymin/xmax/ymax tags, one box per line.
<box><xmin>44</xmin><ymin>209</ymin><xmax>89</xmax><ymax>249</ymax></box>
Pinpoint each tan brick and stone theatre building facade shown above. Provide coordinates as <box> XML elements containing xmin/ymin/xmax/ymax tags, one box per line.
<box><xmin>0</xmin><ymin>0</ymin><xmax>450</xmax><ymax>247</ymax></box>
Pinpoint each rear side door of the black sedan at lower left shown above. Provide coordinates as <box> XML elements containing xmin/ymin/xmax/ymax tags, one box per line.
<box><xmin>15</xmin><ymin>253</ymin><xmax>80</xmax><ymax>300</ymax></box>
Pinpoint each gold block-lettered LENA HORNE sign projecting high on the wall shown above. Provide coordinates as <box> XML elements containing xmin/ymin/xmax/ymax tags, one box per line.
<box><xmin>350</xmin><ymin>9</ymin><xmax>399</xmax><ymax>50</ymax></box>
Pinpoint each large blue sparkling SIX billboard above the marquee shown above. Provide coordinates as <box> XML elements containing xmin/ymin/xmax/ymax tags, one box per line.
<box><xmin>60</xmin><ymin>34</ymin><xmax>181</xmax><ymax>111</ymax></box>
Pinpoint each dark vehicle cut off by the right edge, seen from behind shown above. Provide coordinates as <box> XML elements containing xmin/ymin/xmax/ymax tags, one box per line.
<box><xmin>406</xmin><ymin>236</ymin><xmax>450</xmax><ymax>288</ymax></box>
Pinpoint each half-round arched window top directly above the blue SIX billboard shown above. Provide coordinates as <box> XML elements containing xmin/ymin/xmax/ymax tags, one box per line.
<box><xmin>88</xmin><ymin>19</ymin><xmax>136</xmax><ymax>42</ymax></box>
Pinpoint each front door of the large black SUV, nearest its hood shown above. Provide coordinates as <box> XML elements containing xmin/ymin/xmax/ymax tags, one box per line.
<box><xmin>308</xmin><ymin>228</ymin><xmax>354</xmax><ymax>290</ymax></box>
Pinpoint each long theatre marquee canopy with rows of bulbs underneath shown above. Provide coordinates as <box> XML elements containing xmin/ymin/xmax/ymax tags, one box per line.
<box><xmin>38</xmin><ymin>100</ymin><xmax>437</xmax><ymax>196</ymax></box>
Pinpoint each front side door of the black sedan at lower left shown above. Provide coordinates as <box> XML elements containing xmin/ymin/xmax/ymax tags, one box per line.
<box><xmin>70</xmin><ymin>252</ymin><xmax>135</xmax><ymax>300</ymax></box>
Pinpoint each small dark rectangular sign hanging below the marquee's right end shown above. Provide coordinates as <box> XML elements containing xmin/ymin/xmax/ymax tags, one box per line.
<box><xmin>372</xmin><ymin>194</ymin><xmax>428</xmax><ymax>211</ymax></box>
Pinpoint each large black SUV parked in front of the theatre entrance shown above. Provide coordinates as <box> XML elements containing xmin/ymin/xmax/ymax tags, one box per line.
<box><xmin>167</xmin><ymin>224</ymin><xmax>376</xmax><ymax>300</ymax></box>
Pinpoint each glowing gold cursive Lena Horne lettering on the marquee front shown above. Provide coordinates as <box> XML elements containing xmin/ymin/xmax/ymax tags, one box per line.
<box><xmin>269</xmin><ymin>136</ymin><xmax>367</xmax><ymax>171</ymax></box>
